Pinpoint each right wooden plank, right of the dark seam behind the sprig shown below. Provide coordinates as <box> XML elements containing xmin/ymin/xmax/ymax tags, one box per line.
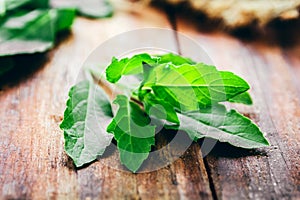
<box><xmin>177</xmin><ymin>14</ymin><xmax>300</xmax><ymax>199</ymax></box>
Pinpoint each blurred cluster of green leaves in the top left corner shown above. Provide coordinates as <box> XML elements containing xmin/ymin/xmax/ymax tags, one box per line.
<box><xmin>0</xmin><ymin>0</ymin><xmax>113</xmax><ymax>76</ymax></box>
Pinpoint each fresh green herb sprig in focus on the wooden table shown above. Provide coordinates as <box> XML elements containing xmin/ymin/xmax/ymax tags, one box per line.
<box><xmin>60</xmin><ymin>53</ymin><xmax>269</xmax><ymax>172</ymax></box>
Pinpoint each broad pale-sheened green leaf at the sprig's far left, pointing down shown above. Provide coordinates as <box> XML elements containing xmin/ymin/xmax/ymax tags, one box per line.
<box><xmin>60</xmin><ymin>81</ymin><xmax>113</xmax><ymax>167</ymax></box>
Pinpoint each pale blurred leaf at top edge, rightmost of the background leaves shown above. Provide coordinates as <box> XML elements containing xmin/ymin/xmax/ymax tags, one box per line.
<box><xmin>51</xmin><ymin>0</ymin><xmax>113</xmax><ymax>18</ymax></box>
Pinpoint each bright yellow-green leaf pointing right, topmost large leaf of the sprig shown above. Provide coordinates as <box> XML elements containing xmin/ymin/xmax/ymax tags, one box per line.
<box><xmin>142</xmin><ymin>63</ymin><xmax>249</xmax><ymax>111</ymax></box>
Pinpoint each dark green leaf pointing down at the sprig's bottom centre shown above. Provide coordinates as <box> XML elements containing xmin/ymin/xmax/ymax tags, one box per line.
<box><xmin>107</xmin><ymin>95</ymin><xmax>155</xmax><ymax>172</ymax></box>
